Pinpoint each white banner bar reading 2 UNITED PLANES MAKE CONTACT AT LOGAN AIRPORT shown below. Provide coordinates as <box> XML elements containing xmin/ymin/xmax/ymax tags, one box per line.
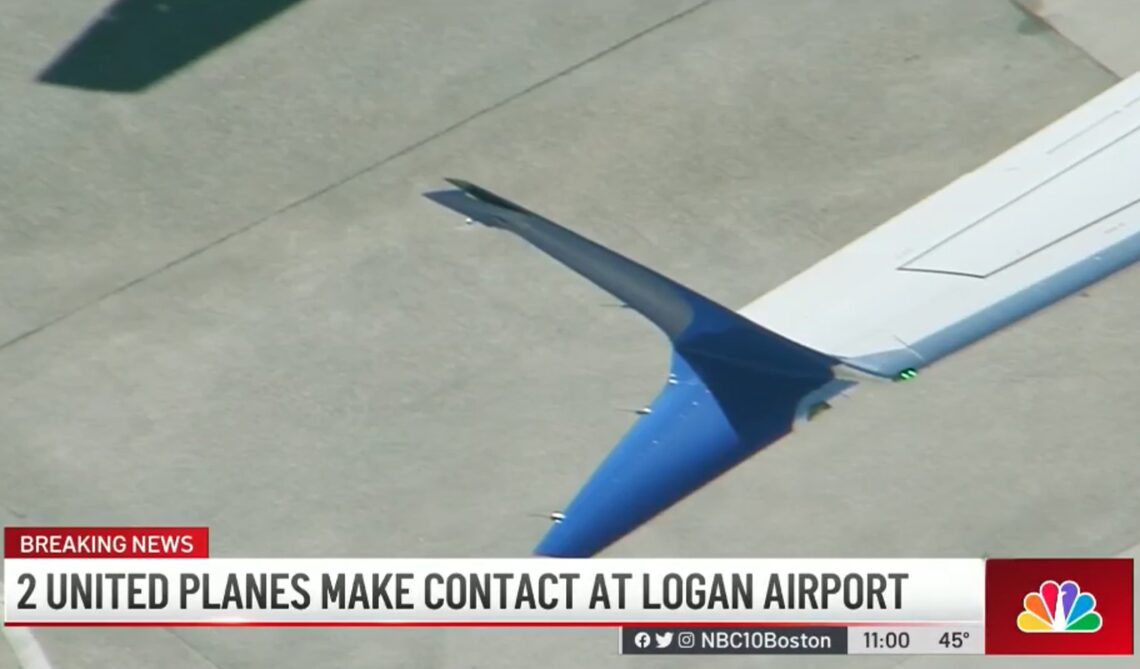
<box><xmin>5</xmin><ymin>558</ymin><xmax>985</xmax><ymax>625</ymax></box>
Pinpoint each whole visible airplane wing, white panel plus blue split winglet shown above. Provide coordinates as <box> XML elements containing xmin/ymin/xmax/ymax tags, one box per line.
<box><xmin>425</xmin><ymin>70</ymin><xmax>1140</xmax><ymax>557</ymax></box>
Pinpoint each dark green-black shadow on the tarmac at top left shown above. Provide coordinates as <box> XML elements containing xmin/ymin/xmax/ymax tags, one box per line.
<box><xmin>36</xmin><ymin>0</ymin><xmax>304</xmax><ymax>92</ymax></box>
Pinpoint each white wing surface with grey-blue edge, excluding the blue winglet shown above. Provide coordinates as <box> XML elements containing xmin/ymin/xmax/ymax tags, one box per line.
<box><xmin>741</xmin><ymin>74</ymin><xmax>1140</xmax><ymax>376</ymax></box>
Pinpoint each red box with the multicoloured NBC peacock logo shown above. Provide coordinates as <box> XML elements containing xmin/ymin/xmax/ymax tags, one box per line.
<box><xmin>986</xmin><ymin>557</ymin><xmax>1134</xmax><ymax>655</ymax></box>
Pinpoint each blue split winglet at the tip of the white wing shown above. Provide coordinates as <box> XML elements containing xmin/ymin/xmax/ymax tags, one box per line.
<box><xmin>424</xmin><ymin>179</ymin><xmax>849</xmax><ymax>556</ymax></box>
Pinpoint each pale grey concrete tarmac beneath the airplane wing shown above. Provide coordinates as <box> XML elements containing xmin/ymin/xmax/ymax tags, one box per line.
<box><xmin>0</xmin><ymin>0</ymin><xmax>1140</xmax><ymax>669</ymax></box>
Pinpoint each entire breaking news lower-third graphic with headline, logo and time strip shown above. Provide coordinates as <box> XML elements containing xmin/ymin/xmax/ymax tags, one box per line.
<box><xmin>3</xmin><ymin>528</ymin><xmax>1133</xmax><ymax>655</ymax></box>
